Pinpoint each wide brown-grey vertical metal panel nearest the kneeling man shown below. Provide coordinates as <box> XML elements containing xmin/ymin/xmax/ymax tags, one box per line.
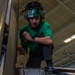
<box><xmin>4</xmin><ymin>0</ymin><xmax>18</xmax><ymax>75</ymax></box>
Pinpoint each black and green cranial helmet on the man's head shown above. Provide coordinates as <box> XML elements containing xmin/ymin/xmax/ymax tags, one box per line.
<box><xmin>25</xmin><ymin>2</ymin><xmax>45</xmax><ymax>19</ymax></box>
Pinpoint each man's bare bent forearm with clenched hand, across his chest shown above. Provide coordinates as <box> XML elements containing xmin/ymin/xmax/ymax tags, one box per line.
<box><xmin>23</xmin><ymin>32</ymin><xmax>53</xmax><ymax>45</ymax></box>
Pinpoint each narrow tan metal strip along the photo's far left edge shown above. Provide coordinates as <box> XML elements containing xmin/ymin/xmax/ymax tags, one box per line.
<box><xmin>0</xmin><ymin>0</ymin><xmax>8</xmax><ymax>53</ymax></box>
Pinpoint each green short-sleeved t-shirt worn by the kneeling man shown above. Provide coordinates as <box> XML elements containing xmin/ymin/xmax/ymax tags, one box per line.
<box><xmin>19</xmin><ymin>21</ymin><xmax>53</xmax><ymax>51</ymax></box>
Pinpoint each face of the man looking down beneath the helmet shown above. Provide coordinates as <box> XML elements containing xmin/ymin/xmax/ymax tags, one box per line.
<box><xmin>29</xmin><ymin>16</ymin><xmax>41</xmax><ymax>29</ymax></box>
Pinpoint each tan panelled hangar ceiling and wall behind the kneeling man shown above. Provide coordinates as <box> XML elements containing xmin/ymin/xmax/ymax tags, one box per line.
<box><xmin>18</xmin><ymin>0</ymin><xmax>75</xmax><ymax>67</ymax></box>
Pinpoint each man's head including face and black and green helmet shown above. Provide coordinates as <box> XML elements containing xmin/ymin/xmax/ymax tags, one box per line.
<box><xmin>25</xmin><ymin>2</ymin><xmax>44</xmax><ymax>28</ymax></box>
